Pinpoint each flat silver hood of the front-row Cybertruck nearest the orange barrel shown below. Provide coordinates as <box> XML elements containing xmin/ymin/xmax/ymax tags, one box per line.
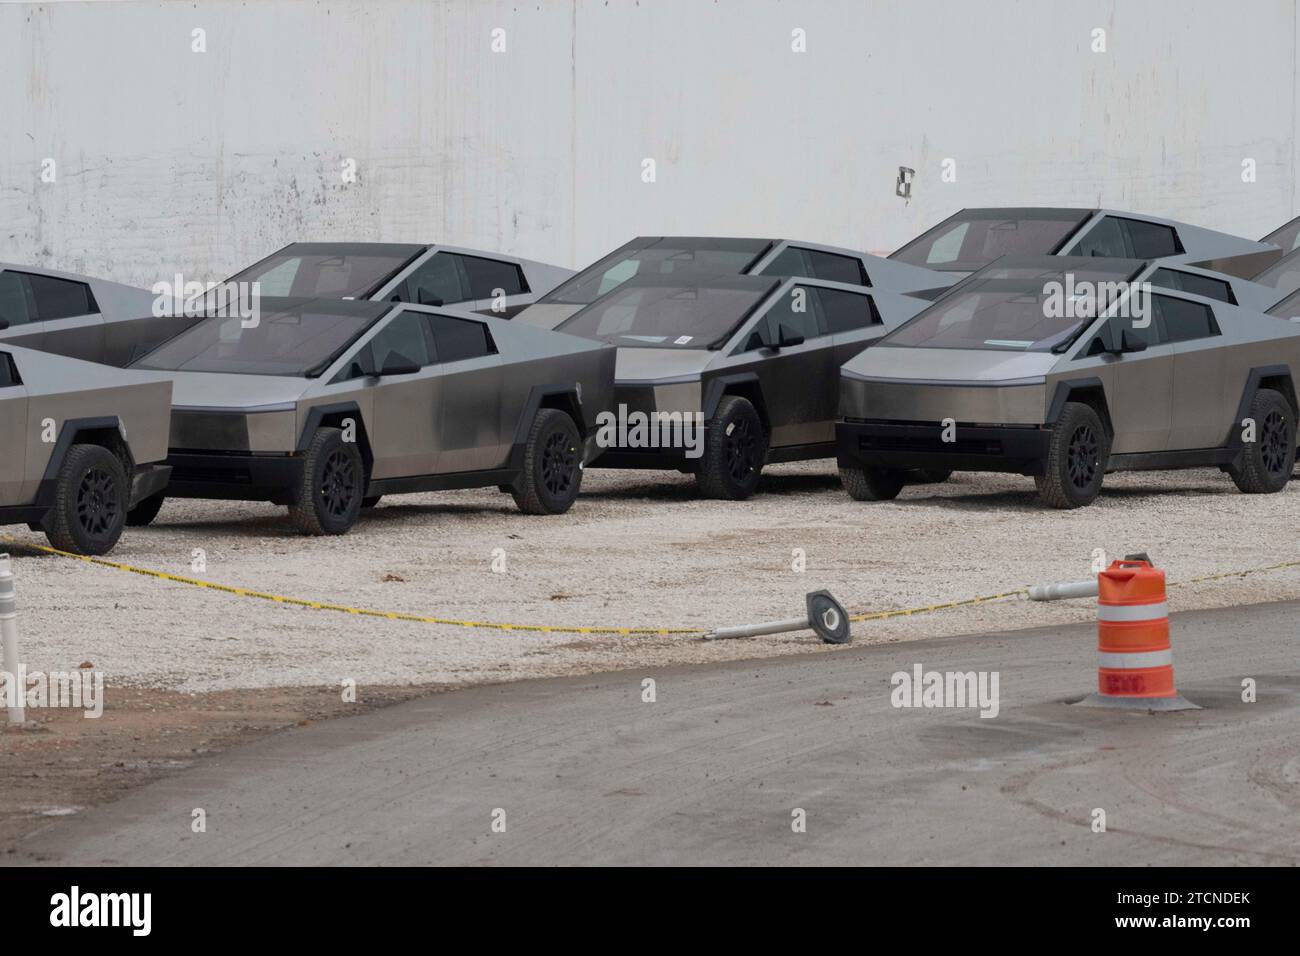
<box><xmin>844</xmin><ymin>346</ymin><xmax>1063</xmax><ymax>384</ymax></box>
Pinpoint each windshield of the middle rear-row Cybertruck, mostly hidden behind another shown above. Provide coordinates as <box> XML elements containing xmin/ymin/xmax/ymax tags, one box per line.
<box><xmin>542</xmin><ymin>239</ymin><xmax>768</xmax><ymax>306</ymax></box>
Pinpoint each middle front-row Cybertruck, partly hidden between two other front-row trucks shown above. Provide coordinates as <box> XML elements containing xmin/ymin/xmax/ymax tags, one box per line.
<box><xmin>548</xmin><ymin>267</ymin><xmax>928</xmax><ymax>499</ymax></box>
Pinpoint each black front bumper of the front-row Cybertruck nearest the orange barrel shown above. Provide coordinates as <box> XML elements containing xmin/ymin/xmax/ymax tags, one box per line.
<box><xmin>835</xmin><ymin>421</ymin><xmax>1052</xmax><ymax>475</ymax></box>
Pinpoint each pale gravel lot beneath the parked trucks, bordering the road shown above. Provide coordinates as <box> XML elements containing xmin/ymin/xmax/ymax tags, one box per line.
<box><xmin>0</xmin><ymin>460</ymin><xmax>1300</xmax><ymax>691</ymax></box>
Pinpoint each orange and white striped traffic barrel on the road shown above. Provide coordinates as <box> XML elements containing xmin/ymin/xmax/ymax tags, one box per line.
<box><xmin>1079</xmin><ymin>558</ymin><xmax>1196</xmax><ymax>710</ymax></box>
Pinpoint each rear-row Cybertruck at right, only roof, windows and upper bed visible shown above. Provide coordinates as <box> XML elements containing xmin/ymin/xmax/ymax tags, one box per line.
<box><xmin>889</xmin><ymin>207</ymin><xmax>1282</xmax><ymax>278</ymax></box>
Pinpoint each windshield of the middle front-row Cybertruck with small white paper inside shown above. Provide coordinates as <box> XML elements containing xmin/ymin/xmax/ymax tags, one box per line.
<box><xmin>558</xmin><ymin>280</ymin><xmax>775</xmax><ymax>349</ymax></box>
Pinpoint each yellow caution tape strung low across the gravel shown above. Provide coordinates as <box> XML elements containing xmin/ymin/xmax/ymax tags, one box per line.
<box><xmin>0</xmin><ymin>535</ymin><xmax>1300</xmax><ymax>635</ymax></box>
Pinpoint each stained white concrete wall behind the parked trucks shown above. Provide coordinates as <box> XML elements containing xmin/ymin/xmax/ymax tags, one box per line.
<box><xmin>0</xmin><ymin>0</ymin><xmax>1300</xmax><ymax>285</ymax></box>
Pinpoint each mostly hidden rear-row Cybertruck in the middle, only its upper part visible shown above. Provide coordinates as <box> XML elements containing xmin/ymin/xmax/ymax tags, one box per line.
<box><xmin>517</xmin><ymin>235</ymin><xmax>958</xmax><ymax>329</ymax></box>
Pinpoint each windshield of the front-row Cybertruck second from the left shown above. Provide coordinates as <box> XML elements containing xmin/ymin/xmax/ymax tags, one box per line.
<box><xmin>133</xmin><ymin>302</ymin><xmax>390</xmax><ymax>376</ymax></box>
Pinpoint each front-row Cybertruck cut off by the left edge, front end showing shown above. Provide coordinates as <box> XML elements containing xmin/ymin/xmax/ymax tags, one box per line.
<box><xmin>0</xmin><ymin>343</ymin><xmax>172</xmax><ymax>554</ymax></box>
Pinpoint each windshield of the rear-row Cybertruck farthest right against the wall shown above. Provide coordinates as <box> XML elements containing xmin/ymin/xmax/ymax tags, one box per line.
<box><xmin>889</xmin><ymin>211</ymin><xmax>1087</xmax><ymax>272</ymax></box>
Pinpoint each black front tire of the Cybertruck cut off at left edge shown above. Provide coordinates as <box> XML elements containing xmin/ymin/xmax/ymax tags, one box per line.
<box><xmin>43</xmin><ymin>445</ymin><xmax>131</xmax><ymax>554</ymax></box>
